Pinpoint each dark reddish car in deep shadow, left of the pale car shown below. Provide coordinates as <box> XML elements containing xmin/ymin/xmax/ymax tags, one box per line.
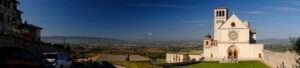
<box><xmin>0</xmin><ymin>47</ymin><xmax>44</xmax><ymax>68</ymax></box>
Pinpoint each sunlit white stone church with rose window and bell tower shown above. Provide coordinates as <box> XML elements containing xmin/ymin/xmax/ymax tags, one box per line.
<box><xmin>203</xmin><ymin>7</ymin><xmax>264</xmax><ymax>61</ymax></box>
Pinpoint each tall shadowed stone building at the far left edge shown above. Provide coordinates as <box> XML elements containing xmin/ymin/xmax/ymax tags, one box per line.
<box><xmin>0</xmin><ymin>0</ymin><xmax>22</xmax><ymax>34</ymax></box>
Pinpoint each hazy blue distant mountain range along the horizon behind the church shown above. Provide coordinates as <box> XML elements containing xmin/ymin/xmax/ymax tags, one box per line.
<box><xmin>42</xmin><ymin>36</ymin><xmax>289</xmax><ymax>46</ymax></box>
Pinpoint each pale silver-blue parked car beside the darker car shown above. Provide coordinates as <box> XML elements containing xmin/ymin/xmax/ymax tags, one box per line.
<box><xmin>42</xmin><ymin>52</ymin><xmax>72</xmax><ymax>68</ymax></box>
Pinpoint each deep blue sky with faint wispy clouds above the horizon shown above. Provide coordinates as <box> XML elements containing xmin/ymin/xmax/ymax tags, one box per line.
<box><xmin>18</xmin><ymin>0</ymin><xmax>300</xmax><ymax>40</ymax></box>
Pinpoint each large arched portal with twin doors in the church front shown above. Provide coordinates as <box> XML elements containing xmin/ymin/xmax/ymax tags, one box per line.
<box><xmin>227</xmin><ymin>45</ymin><xmax>239</xmax><ymax>58</ymax></box>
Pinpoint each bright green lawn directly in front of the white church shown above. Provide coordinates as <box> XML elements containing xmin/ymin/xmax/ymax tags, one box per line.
<box><xmin>183</xmin><ymin>61</ymin><xmax>269</xmax><ymax>68</ymax></box>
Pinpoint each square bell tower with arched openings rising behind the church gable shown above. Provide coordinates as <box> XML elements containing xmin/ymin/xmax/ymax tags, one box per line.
<box><xmin>214</xmin><ymin>7</ymin><xmax>228</xmax><ymax>40</ymax></box>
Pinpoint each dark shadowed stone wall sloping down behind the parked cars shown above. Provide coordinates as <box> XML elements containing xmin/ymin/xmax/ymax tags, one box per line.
<box><xmin>0</xmin><ymin>35</ymin><xmax>69</xmax><ymax>57</ymax></box>
